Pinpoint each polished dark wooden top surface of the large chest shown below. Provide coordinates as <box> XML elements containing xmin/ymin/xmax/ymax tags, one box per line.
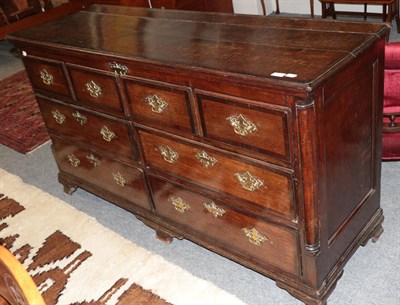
<box><xmin>9</xmin><ymin>5</ymin><xmax>389</xmax><ymax>87</ymax></box>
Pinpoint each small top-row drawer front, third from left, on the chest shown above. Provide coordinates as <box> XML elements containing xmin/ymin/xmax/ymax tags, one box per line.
<box><xmin>124</xmin><ymin>79</ymin><xmax>193</xmax><ymax>133</ymax></box>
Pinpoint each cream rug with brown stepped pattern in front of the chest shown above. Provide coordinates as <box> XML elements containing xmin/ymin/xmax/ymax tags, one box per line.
<box><xmin>0</xmin><ymin>169</ymin><xmax>244</xmax><ymax>305</ymax></box>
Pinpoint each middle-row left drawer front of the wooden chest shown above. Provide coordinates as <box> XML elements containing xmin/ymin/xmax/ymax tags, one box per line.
<box><xmin>38</xmin><ymin>98</ymin><xmax>137</xmax><ymax>160</ymax></box>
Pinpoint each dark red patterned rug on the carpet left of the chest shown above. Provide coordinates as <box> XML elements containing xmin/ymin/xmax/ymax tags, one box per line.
<box><xmin>0</xmin><ymin>70</ymin><xmax>49</xmax><ymax>154</ymax></box>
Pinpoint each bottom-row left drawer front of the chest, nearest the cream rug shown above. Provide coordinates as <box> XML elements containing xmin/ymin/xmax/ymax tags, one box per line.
<box><xmin>52</xmin><ymin>137</ymin><xmax>151</xmax><ymax>209</ymax></box>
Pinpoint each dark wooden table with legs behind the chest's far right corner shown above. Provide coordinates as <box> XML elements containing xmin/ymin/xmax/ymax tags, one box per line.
<box><xmin>320</xmin><ymin>0</ymin><xmax>400</xmax><ymax>33</ymax></box>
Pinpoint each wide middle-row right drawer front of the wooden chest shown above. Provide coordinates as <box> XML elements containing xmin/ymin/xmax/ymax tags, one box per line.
<box><xmin>139</xmin><ymin>130</ymin><xmax>294</xmax><ymax>217</ymax></box>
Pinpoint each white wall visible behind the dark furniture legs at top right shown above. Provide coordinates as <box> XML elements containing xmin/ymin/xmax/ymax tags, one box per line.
<box><xmin>233</xmin><ymin>0</ymin><xmax>382</xmax><ymax>15</ymax></box>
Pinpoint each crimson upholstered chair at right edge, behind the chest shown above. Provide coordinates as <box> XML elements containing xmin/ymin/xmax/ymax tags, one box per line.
<box><xmin>382</xmin><ymin>42</ymin><xmax>400</xmax><ymax>160</ymax></box>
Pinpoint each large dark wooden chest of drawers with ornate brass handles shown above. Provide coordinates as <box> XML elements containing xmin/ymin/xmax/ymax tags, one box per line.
<box><xmin>10</xmin><ymin>5</ymin><xmax>389</xmax><ymax>305</ymax></box>
